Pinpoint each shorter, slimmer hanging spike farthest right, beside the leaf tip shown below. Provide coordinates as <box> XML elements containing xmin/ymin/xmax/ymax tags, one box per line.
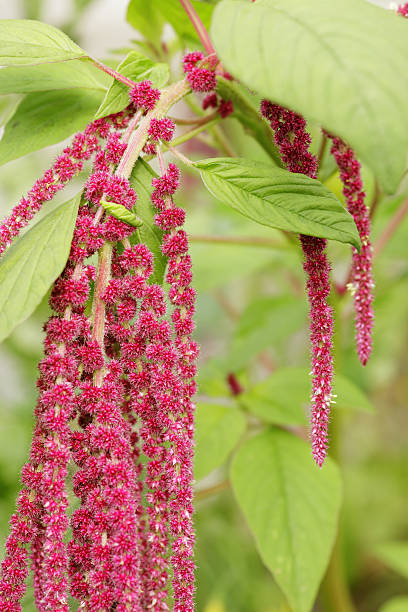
<box><xmin>331</xmin><ymin>138</ymin><xmax>374</xmax><ymax>365</ymax></box>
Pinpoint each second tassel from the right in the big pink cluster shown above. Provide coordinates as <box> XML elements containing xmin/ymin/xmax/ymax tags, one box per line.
<box><xmin>103</xmin><ymin>244</ymin><xmax>172</xmax><ymax>611</ymax></box>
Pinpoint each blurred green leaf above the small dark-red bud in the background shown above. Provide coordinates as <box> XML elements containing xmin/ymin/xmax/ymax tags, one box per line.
<box><xmin>228</xmin><ymin>296</ymin><xmax>306</xmax><ymax>371</ymax></box>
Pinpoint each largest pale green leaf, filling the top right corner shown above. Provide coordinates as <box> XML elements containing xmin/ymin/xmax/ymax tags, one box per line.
<box><xmin>211</xmin><ymin>0</ymin><xmax>408</xmax><ymax>192</ymax></box>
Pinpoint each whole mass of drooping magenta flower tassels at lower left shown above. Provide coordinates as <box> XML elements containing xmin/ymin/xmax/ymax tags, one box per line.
<box><xmin>0</xmin><ymin>83</ymin><xmax>198</xmax><ymax>612</ymax></box>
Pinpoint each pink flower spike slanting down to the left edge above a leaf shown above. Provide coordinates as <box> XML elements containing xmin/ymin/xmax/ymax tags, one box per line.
<box><xmin>0</xmin><ymin>119</ymin><xmax>110</xmax><ymax>255</ymax></box>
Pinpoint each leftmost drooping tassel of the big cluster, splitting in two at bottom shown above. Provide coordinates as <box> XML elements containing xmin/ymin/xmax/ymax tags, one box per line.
<box><xmin>0</xmin><ymin>192</ymin><xmax>101</xmax><ymax>612</ymax></box>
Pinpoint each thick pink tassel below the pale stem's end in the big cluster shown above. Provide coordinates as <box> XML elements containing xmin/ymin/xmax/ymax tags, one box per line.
<box><xmin>69</xmin><ymin>362</ymin><xmax>142</xmax><ymax>612</ymax></box>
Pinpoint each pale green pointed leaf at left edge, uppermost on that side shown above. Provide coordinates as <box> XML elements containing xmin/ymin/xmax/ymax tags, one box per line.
<box><xmin>0</xmin><ymin>19</ymin><xmax>87</xmax><ymax>66</ymax></box>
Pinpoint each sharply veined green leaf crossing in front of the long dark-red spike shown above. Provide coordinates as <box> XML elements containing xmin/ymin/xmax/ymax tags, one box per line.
<box><xmin>194</xmin><ymin>157</ymin><xmax>360</xmax><ymax>249</ymax></box>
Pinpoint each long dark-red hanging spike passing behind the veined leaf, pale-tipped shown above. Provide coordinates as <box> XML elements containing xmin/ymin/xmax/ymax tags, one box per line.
<box><xmin>261</xmin><ymin>100</ymin><xmax>333</xmax><ymax>467</ymax></box>
